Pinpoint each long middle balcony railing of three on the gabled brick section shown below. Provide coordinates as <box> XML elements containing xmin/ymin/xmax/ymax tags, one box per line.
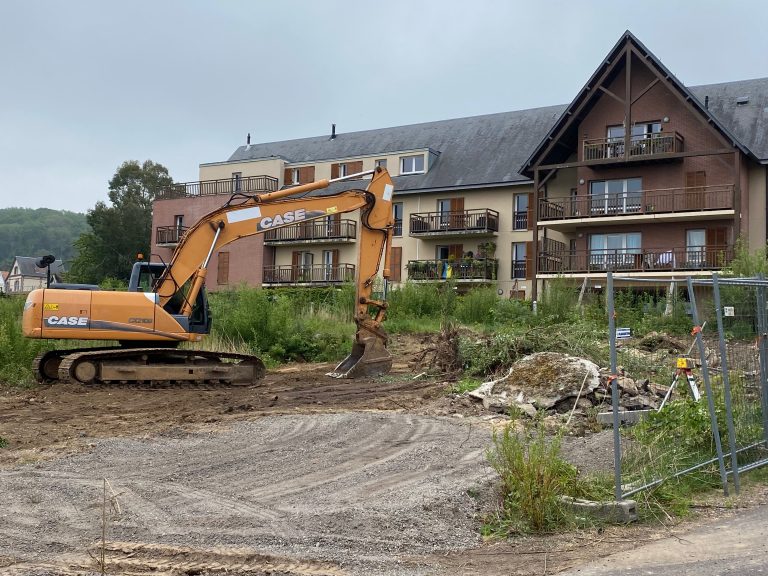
<box><xmin>539</xmin><ymin>184</ymin><xmax>734</xmax><ymax>220</ymax></box>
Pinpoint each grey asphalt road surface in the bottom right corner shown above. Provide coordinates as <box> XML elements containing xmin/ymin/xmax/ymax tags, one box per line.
<box><xmin>560</xmin><ymin>506</ymin><xmax>768</xmax><ymax>576</ymax></box>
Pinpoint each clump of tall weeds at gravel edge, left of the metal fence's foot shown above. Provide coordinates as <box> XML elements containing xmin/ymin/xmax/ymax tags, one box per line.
<box><xmin>483</xmin><ymin>423</ymin><xmax>612</xmax><ymax>536</ymax></box>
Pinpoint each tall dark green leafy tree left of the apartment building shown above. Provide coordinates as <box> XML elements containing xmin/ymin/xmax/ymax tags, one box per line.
<box><xmin>68</xmin><ymin>160</ymin><xmax>173</xmax><ymax>283</ymax></box>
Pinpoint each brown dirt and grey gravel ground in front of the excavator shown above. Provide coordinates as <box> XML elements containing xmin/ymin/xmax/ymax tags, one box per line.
<box><xmin>0</xmin><ymin>341</ymin><xmax>766</xmax><ymax>576</ymax></box>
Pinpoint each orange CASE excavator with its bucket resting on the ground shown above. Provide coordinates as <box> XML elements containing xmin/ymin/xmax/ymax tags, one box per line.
<box><xmin>22</xmin><ymin>168</ymin><xmax>394</xmax><ymax>385</ymax></box>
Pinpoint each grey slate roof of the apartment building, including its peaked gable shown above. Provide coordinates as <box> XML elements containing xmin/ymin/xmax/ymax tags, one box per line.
<box><xmin>227</xmin><ymin>31</ymin><xmax>768</xmax><ymax>194</ymax></box>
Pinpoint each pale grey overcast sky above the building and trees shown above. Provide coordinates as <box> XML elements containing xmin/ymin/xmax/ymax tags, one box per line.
<box><xmin>0</xmin><ymin>0</ymin><xmax>768</xmax><ymax>212</ymax></box>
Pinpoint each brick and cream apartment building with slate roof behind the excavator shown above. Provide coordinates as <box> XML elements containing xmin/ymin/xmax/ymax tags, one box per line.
<box><xmin>152</xmin><ymin>32</ymin><xmax>768</xmax><ymax>298</ymax></box>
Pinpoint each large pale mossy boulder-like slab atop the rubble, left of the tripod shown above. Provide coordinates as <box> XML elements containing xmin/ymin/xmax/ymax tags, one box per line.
<box><xmin>491</xmin><ymin>352</ymin><xmax>600</xmax><ymax>410</ymax></box>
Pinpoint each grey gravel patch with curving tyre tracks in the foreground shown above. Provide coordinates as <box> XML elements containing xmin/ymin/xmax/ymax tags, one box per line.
<box><xmin>0</xmin><ymin>412</ymin><xmax>491</xmax><ymax>574</ymax></box>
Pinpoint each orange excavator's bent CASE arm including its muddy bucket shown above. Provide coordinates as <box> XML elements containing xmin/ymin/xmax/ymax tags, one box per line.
<box><xmin>155</xmin><ymin>168</ymin><xmax>394</xmax><ymax>377</ymax></box>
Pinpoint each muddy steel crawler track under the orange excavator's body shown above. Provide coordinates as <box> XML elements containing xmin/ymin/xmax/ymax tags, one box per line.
<box><xmin>35</xmin><ymin>348</ymin><xmax>266</xmax><ymax>388</ymax></box>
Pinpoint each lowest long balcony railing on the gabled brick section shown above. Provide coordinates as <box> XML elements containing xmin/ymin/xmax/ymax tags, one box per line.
<box><xmin>539</xmin><ymin>245</ymin><xmax>734</xmax><ymax>274</ymax></box>
